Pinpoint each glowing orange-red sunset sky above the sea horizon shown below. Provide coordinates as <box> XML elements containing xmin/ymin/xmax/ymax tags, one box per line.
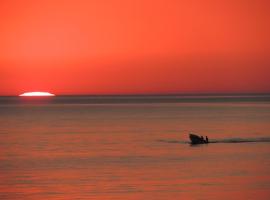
<box><xmin>0</xmin><ymin>0</ymin><xmax>270</xmax><ymax>95</ymax></box>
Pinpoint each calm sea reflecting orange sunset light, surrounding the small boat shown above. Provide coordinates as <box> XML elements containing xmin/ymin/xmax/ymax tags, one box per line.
<box><xmin>0</xmin><ymin>95</ymin><xmax>270</xmax><ymax>200</ymax></box>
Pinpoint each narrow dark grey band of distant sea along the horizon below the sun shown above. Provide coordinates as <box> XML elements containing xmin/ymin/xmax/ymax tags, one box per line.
<box><xmin>0</xmin><ymin>94</ymin><xmax>270</xmax><ymax>104</ymax></box>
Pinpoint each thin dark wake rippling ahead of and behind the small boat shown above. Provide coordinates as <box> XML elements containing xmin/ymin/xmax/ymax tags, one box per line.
<box><xmin>157</xmin><ymin>137</ymin><xmax>270</xmax><ymax>144</ymax></box>
